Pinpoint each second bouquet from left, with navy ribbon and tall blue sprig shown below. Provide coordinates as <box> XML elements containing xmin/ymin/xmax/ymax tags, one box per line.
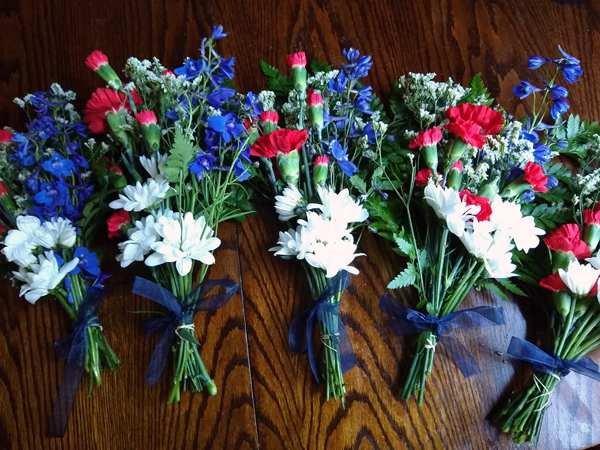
<box><xmin>84</xmin><ymin>27</ymin><xmax>259</xmax><ymax>402</ymax></box>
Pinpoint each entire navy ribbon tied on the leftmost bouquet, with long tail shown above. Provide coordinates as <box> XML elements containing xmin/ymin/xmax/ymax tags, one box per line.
<box><xmin>48</xmin><ymin>288</ymin><xmax>106</xmax><ymax>437</ymax></box>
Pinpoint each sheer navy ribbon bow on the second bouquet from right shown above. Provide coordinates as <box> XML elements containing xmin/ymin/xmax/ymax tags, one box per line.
<box><xmin>379</xmin><ymin>293</ymin><xmax>506</xmax><ymax>378</ymax></box>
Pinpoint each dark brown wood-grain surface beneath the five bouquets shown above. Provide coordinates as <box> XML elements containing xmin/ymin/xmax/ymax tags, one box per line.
<box><xmin>0</xmin><ymin>0</ymin><xmax>600</xmax><ymax>450</ymax></box>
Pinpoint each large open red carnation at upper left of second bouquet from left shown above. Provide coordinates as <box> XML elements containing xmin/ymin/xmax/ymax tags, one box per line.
<box><xmin>83</xmin><ymin>88</ymin><xmax>142</xmax><ymax>134</ymax></box>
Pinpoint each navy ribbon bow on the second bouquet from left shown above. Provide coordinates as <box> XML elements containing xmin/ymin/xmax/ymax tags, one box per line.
<box><xmin>133</xmin><ymin>277</ymin><xmax>238</xmax><ymax>386</ymax></box>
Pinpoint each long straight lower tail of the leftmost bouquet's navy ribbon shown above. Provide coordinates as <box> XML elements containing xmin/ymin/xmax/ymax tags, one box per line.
<box><xmin>47</xmin><ymin>327</ymin><xmax>89</xmax><ymax>438</ymax></box>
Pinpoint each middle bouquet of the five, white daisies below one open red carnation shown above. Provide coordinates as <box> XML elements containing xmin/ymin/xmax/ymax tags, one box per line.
<box><xmin>251</xmin><ymin>49</ymin><xmax>385</xmax><ymax>407</ymax></box>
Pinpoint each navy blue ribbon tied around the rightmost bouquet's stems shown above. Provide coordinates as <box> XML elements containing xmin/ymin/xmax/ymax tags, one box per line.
<box><xmin>506</xmin><ymin>336</ymin><xmax>600</xmax><ymax>381</ymax></box>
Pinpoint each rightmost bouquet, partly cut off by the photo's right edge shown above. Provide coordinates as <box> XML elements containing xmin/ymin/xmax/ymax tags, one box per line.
<box><xmin>492</xmin><ymin>46</ymin><xmax>600</xmax><ymax>443</ymax></box>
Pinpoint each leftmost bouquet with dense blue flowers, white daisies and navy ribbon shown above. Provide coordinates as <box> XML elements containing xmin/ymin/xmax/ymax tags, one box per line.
<box><xmin>0</xmin><ymin>84</ymin><xmax>124</xmax><ymax>437</ymax></box>
